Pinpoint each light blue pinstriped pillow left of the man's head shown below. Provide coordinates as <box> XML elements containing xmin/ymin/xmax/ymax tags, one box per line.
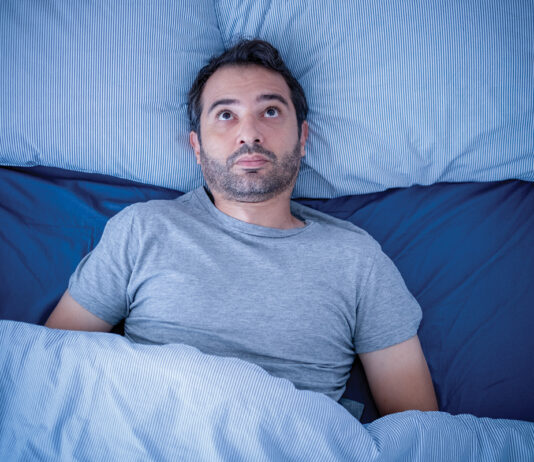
<box><xmin>0</xmin><ymin>0</ymin><xmax>223</xmax><ymax>190</ymax></box>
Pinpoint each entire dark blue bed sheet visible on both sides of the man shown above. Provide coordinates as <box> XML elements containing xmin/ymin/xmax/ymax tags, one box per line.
<box><xmin>0</xmin><ymin>168</ymin><xmax>534</xmax><ymax>421</ymax></box>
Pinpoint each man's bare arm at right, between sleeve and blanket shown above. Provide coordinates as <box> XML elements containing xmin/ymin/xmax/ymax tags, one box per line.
<box><xmin>360</xmin><ymin>335</ymin><xmax>438</xmax><ymax>415</ymax></box>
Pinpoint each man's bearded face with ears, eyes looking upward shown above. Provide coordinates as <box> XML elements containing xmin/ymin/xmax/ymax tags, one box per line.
<box><xmin>190</xmin><ymin>65</ymin><xmax>308</xmax><ymax>202</ymax></box>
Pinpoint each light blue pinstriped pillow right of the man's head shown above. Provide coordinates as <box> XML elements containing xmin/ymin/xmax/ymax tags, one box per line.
<box><xmin>216</xmin><ymin>0</ymin><xmax>534</xmax><ymax>197</ymax></box>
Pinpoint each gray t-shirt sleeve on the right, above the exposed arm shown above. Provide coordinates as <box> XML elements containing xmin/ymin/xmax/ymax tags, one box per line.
<box><xmin>354</xmin><ymin>244</ymin><xmax>422</xmax><ymax>353</ymax></box>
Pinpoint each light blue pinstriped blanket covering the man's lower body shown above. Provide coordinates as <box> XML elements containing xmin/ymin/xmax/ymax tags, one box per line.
<box><xmin>0</xmin><ymin>321</ymin><xmax>534</xmax><ymax>462</ymax></box>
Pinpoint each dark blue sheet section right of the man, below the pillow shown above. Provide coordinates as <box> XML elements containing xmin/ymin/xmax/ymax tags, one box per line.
<box><xmin>301</xmin><ymin>181</ymin><xmax>534</xmax><ymax>421</ymax></box>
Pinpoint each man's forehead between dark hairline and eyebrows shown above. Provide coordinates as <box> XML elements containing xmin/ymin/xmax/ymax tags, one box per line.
<box><xmin>201</xmin><ymin>64</ymin><xmax>291</xmax><ymax>109</ymax></box>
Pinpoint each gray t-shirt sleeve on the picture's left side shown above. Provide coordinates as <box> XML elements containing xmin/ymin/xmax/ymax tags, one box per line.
<box><xmin>68</xmin><ymin>207</ymin><xmax>137</xmax><ymax>325</ymax></box>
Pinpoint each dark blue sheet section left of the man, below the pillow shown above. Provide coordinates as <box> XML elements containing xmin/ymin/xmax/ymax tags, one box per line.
<box><xmin>0</xmin><ymin>167</ymin><xmax>180</xmax><ymax>324</ymax></box>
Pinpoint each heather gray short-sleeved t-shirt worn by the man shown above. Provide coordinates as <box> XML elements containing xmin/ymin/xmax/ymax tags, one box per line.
<box><xmin>69</xmin><ymin>188</ymin><xmax>421</xmax><ymax>400</ymax></box>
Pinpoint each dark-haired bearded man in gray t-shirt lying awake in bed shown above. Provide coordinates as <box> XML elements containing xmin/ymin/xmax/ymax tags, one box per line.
<box><xmin>46</xmin><ymin>40</ymin><xmax>437</xmax><ymax>414</ymax></box>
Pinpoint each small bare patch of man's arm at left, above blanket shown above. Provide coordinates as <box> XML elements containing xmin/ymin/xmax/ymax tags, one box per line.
<box><xmin>45</xmin><ymin>290</ymin><xmax>113</xmax><ymax>332</ymax></box>
